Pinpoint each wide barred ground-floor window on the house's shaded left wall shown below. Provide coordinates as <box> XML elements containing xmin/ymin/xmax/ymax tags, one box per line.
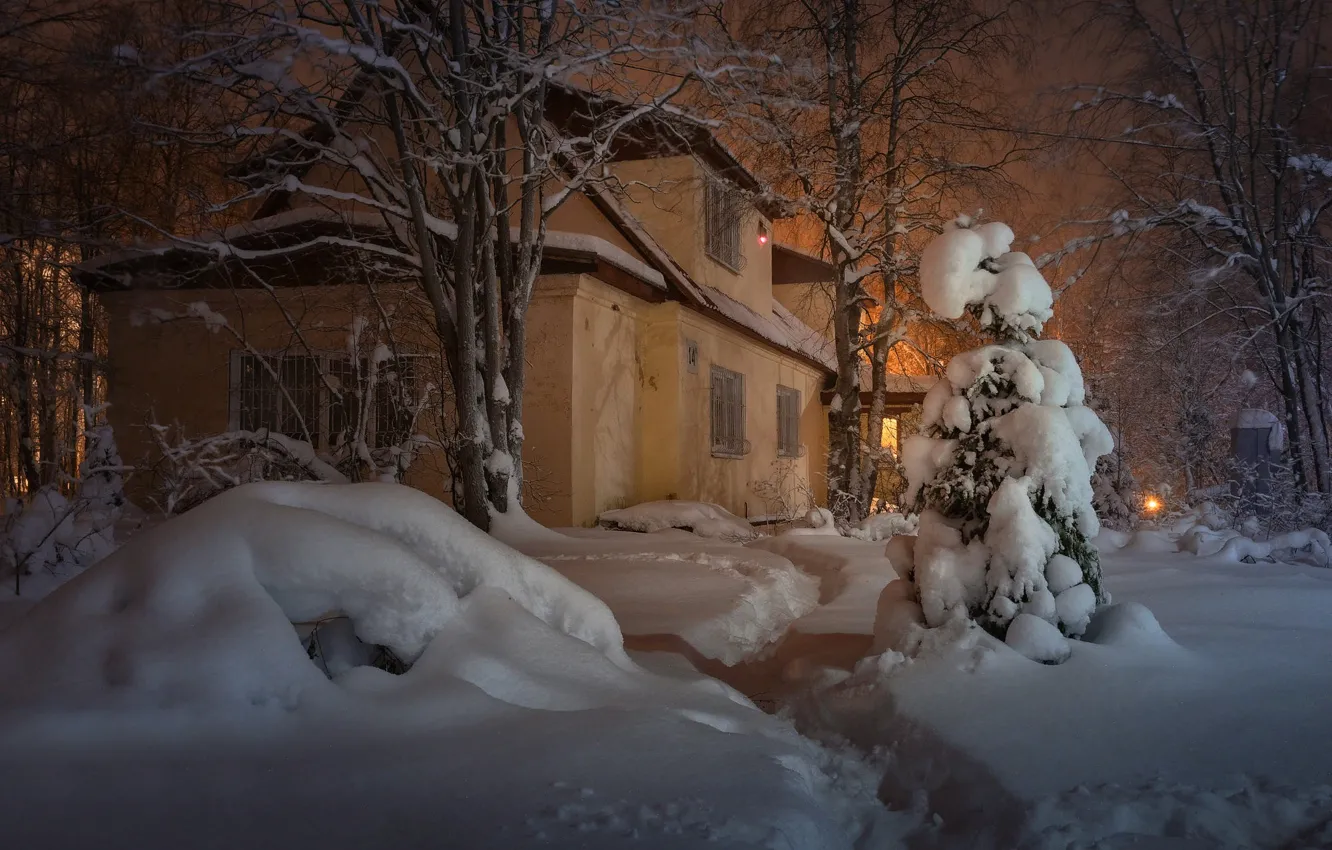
<box><xmin>229</xmin><ymin>350</ymin><xmax>416</xmax><ymax>450</ymax></box>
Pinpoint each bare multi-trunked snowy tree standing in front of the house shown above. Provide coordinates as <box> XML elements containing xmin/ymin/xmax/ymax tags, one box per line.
<box><xmin>155</xmin><ymin>0</ymin><xmax>735</xmax><ymax>528</ymax></box>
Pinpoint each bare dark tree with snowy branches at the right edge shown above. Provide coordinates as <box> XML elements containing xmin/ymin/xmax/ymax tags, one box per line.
<box><xmin>1071</xmin><ymin>0</ymin><xmax>1332</xmax><ymax>493</ymax></box>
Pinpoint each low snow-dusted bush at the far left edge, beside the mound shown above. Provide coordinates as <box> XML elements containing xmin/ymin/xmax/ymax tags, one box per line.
<box><xmin>0</xmin><ymin>408</ymin><xmax>125</xmax><ymax>596</ymax></box>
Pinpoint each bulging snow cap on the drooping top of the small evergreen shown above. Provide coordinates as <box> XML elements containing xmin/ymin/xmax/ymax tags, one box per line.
<box><xmin>920</xmin><ymin>222</ymin><xmax>1054</xmax><ymax>337</ymax></box>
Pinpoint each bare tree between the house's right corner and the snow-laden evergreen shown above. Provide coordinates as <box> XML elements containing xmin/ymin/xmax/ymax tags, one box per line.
<box><xmin>722</xmin><ymin>0</ymin><xmax>1016</xmax><ymax>522</ymax></box>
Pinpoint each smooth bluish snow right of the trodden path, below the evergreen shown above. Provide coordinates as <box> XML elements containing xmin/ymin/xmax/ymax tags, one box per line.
<box><xmin>777</xmin><ymin>535</ymin><xmax>1332</xmax><ymax>850</ymax></box>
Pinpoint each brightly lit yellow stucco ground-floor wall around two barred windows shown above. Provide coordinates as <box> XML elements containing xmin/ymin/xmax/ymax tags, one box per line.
<box><xmin>523</xmin><ymin>276</ymin><xmax>827</xmax><ymax>525</ymax></box>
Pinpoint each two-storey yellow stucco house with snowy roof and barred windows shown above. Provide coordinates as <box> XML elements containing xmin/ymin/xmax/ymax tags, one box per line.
<box><xmin>77</xmin><ymin>89</ymin><xmax>927</xmax><ymax>526</ymax></box>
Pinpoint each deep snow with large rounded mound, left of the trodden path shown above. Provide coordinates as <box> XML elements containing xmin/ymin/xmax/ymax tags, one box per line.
<box><xmin>0</xmin><ymin>484</ymin><xmax>904</xmax><ymax>850</ymax></box>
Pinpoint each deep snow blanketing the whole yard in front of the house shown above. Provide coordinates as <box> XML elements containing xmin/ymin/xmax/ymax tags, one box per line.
<box><xmin>0</xmin><ymin>484</ymin><xmax>1332</xmax><ymax>850</ymax></box>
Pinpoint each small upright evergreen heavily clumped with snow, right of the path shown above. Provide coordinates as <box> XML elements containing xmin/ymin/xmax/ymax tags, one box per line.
<box><xmin>903</xmin><ymin>215</ymin><xmax>1114</xmax><ymax>647</ymax></box>
